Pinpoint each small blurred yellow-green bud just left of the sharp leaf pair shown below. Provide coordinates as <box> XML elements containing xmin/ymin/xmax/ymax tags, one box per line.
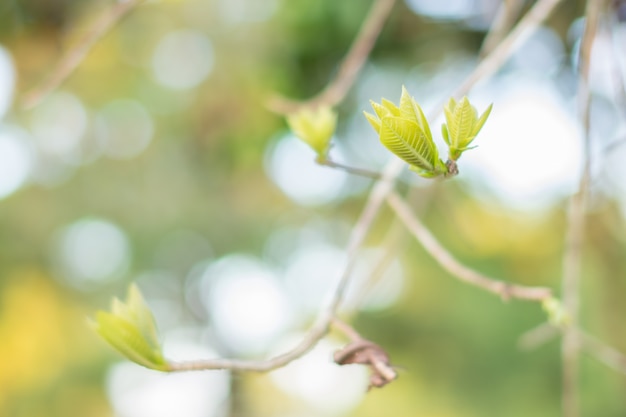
<box><xmin>287</xmin><ymin>106</ymin><xmax>337</xmax><ymax>159</ymax></box>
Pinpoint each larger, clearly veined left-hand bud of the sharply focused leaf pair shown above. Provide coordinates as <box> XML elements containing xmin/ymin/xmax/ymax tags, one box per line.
<box><xmin>365</xmin><ymin>87</ymin><xmax>447</xmax><ymax>178</ymax></box>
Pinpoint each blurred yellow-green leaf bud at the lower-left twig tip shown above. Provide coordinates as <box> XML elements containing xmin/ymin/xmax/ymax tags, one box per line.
<box><xmin>92</xmin><ymin>284</ymin><xmax>169</xmax><ymax>371</ymax></box>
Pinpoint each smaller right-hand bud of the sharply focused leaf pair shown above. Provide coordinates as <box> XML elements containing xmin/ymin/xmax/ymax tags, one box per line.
<box><xmin>441</xmin><ymin>97</ymin><xmax>493</xmax><ymax>161</ymax></box>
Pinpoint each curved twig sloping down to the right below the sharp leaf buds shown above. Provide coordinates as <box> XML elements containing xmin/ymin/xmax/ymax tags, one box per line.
<box><xmin>387</xmin><ymin>192</ymin><xmax>551</xmax><ymax>301</ymax></box>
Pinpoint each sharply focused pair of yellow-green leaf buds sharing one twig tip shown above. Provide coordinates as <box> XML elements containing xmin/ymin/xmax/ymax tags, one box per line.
<box><xmin>364</xmin><ymin>86</ymin><xmax>491</xmax><ymax>178</ymax></box>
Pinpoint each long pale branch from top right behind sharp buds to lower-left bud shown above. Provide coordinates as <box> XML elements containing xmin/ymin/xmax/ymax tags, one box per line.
<box><xmin>171</xmin><ymin>0</ymin><xmax>560</xmax><ymax>372</ymax></box>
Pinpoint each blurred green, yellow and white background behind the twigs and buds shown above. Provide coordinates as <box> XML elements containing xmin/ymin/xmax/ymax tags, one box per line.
<box><xmin>0</xmin><ymin>0</ymin><xmax>626</xmax><ymax>417</ymax></box>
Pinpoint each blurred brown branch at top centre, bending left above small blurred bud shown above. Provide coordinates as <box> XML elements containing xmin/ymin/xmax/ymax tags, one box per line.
<box><xmin>267</xmin><ymin>0</ymin><xmax>396</xmax><ymax>114</ymax></box>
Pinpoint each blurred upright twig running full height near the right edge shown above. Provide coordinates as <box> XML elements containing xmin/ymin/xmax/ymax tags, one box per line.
<box><xmin>561</xmin><ymin>0</ymin><xmax>601</xmax><ymax>417</ymax></box>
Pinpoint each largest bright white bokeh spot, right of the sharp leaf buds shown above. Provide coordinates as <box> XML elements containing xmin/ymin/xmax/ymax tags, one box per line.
<box><xmin>461</xmin><ymin>74</ymin><xmax>582</xmax><ymax>209</ymax></box>
